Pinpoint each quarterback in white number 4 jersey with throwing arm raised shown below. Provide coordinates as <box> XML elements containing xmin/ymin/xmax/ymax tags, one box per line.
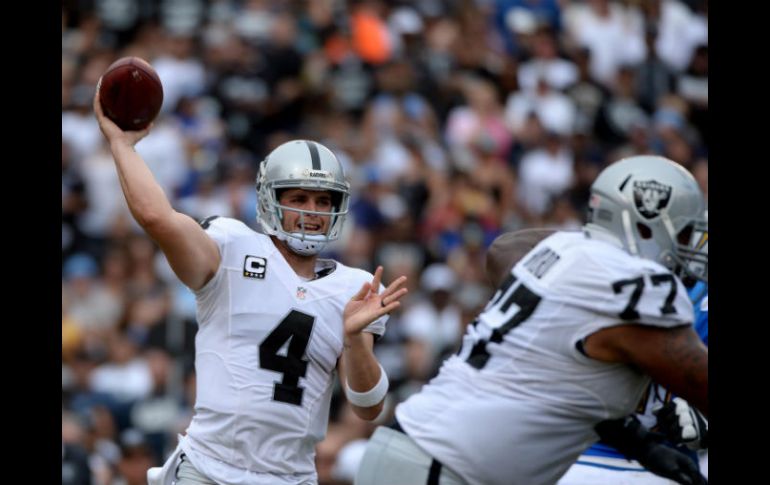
<box><xmin>93</xmin><ymin>94</ymin><xmax>406</xmax><ymax>485</ymax></box>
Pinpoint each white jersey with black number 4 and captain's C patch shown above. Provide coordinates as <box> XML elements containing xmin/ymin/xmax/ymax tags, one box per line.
<box><xmin>182</xmin><ymin>218</ymin><xmax>387</xmax><ymax>485</ymax></box>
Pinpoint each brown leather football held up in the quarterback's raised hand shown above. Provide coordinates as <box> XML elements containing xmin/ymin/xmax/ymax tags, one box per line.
<box><xmin>99</xmin><ymin>57</ymin><xmax>163</xmax><ymax>131</ymax></box>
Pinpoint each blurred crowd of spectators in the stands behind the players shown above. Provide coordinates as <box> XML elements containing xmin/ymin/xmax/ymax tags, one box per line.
<box><xmin>61</xmin><ymin>0</ymin><xmax>709</xmax><ymax>485</ymax></box>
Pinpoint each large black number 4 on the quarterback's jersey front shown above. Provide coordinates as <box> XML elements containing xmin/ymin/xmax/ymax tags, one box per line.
<box><xmin>259</xmin><ymin>310</ymin><xmax>315</xmax><ymax>406</ymax></box>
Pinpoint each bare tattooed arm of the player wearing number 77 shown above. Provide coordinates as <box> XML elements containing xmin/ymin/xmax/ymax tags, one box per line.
<box><xmin>584</xmin><ymin>324</ymin><xmax>708</xmax><ymax>416</ymax></box>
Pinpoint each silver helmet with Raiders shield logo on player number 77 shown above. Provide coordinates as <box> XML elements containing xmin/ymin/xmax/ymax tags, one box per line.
<box><xmin>585</xmin><ymin>155</ymin><xmax>708</xmax><ymax>282</ymax></box>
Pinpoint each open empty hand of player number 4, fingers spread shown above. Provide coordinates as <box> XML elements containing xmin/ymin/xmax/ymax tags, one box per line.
<box><xmin>342</xmin><ymin>266</ymin><xmax>408</xmax><ymax>335</ymax></box>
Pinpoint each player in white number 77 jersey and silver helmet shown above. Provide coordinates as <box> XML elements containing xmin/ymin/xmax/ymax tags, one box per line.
<box><xmin>356</xmin><ymin>156</ymin><xmax>708</xmax><ymax>485</ymax></box>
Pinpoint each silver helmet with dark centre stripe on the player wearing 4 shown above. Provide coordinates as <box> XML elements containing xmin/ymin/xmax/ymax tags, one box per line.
<box><xmin>257</xmin><ymin>140</ymin><xmax>350</xmax><ymax>256</ymax></box>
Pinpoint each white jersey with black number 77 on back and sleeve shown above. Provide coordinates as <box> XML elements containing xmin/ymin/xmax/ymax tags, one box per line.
<box><xmin>396</xmin><ymin>232</ymin><xmax>693</xmax><ymax>485</ymax></box>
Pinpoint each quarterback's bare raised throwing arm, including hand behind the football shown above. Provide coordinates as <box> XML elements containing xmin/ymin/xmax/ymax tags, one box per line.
<box><xmin>93</xmin><ymin>89</ymin><xmax>220</xmax><ymax>290</ymax></box>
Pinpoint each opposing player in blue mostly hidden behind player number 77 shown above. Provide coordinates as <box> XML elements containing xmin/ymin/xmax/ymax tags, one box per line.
<box><xmin>486</xmin><ymin>229</ymin><xmax>708</xmax><ymax>485</ymax></box>
